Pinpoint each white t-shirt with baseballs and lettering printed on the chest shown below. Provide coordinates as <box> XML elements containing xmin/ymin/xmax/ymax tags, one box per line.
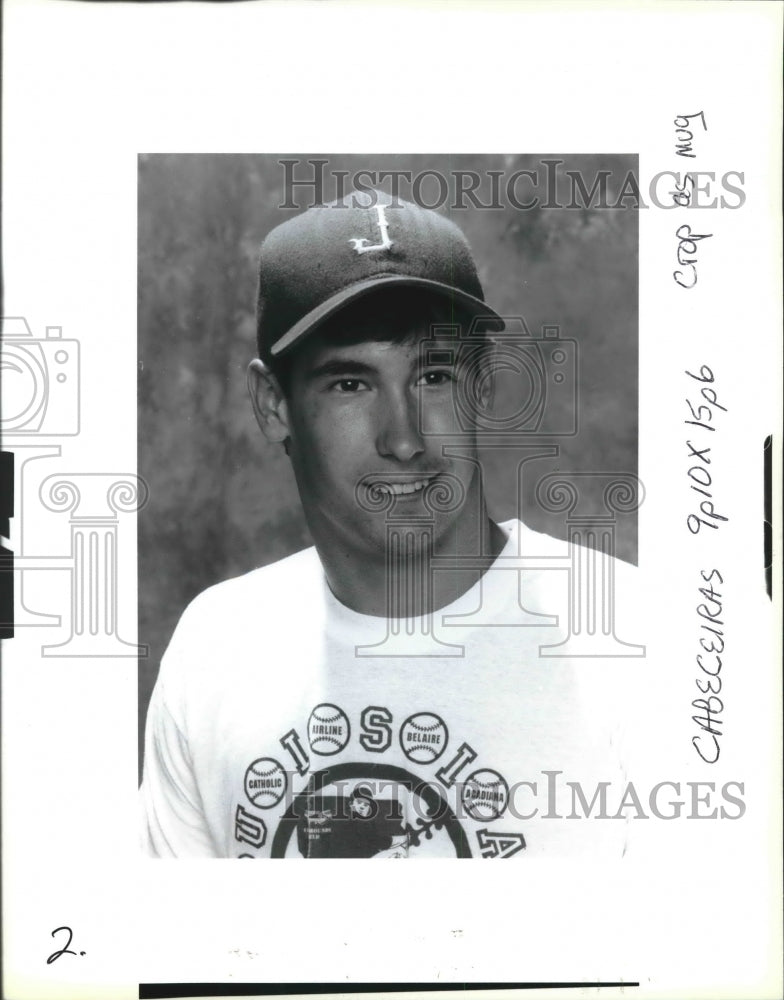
<box><xmin>141</xmin><ymin>521</ymin><xmax>644</xmax><ymax>858</ymax></box>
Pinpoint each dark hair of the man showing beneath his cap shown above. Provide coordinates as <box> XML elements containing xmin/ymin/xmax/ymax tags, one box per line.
<box><xmin>262</xmin><ymin>286</ymin><xmax>481</xmax><ymax>396</ymax></box>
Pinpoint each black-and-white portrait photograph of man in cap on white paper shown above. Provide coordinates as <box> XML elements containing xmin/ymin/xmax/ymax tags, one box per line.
<box><xmin>139</xmin><ymin>155</ymin><xmax>645</xmax><ymax>858</ymax></box>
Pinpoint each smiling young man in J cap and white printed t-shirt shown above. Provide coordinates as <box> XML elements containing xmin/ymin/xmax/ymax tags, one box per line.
<box><xmin>142</xmin><ymin>192</ymin><xmax>640</xmax><ymax>858</ymax></box>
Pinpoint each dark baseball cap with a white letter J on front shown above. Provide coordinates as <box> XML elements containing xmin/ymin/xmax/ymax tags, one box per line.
<box><xmin>257</xmin><ymin>190</ymin><xmax>504</xmax><ymax>359</ymax></box>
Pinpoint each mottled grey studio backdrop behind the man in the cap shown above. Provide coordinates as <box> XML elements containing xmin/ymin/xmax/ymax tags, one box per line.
<box><xmin>138</xmin><ymin>154</ymin><xmax>638</xmax><ymax>768</ymax></box>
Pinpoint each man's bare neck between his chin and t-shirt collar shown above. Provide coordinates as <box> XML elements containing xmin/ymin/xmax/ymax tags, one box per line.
<box><xmin>316</xmin><ymin>512</ymin><xmax>506</xmax><ymax>618</ymax></box>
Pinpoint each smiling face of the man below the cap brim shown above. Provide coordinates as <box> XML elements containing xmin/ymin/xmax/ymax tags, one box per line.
<box><xmin>288</xmin><ymin>321</ymin><xmax>490</xmax><ymax>555</ymax></box>
